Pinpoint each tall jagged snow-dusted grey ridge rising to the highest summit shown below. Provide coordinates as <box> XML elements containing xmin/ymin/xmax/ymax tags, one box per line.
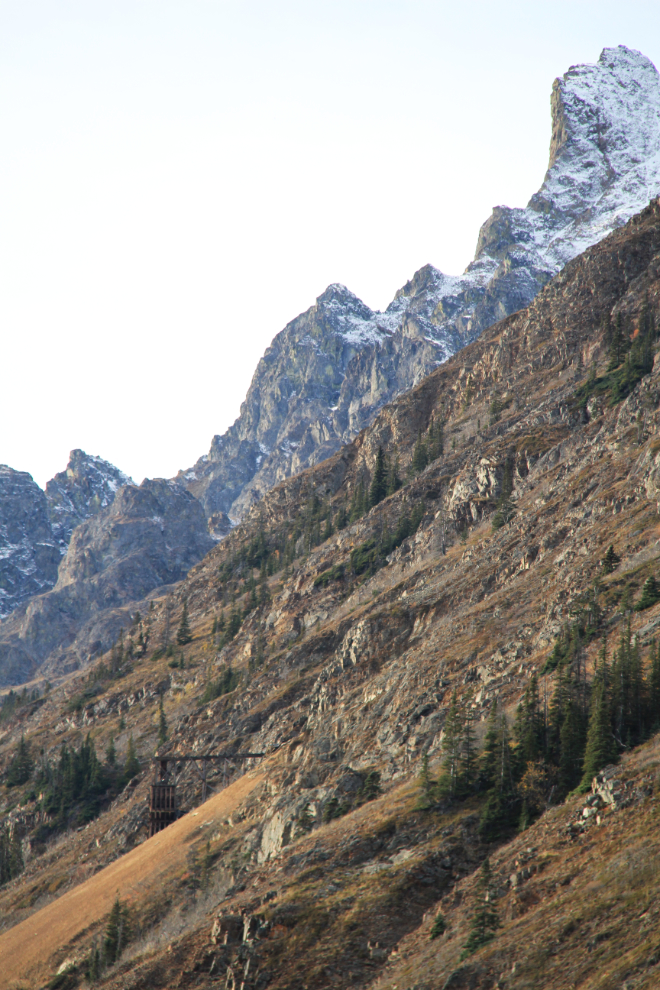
<box><xmin>179</xmin><ymin>46</ymin><xmax>660</xmax><ymax>518</ymax></box>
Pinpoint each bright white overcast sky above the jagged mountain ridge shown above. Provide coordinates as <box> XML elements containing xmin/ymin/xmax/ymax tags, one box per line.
<box><xmin>0</xmin><ymin>0</ymin><xmax>660</xmax><ymax>485</ymax></box>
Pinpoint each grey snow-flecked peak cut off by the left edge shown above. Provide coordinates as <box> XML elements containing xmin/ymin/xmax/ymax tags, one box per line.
<box><xmin>0</xmin><ymin>464</ymin><xmax>60</xmax><ymax>617</ymax></box>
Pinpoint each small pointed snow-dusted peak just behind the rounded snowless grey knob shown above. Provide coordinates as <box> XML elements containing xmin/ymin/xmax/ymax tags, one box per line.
<box><xmin>46</xmin><ymin>450</ymin><xmax>134</xmax><ymax>552</ymax></box>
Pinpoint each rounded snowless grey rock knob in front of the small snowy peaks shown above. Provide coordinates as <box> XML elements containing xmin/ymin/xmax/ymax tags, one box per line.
<box><xmin>0</xmin><ymin>479</ymin><xmax>214</xmax><ymax>684</ymax></box>
